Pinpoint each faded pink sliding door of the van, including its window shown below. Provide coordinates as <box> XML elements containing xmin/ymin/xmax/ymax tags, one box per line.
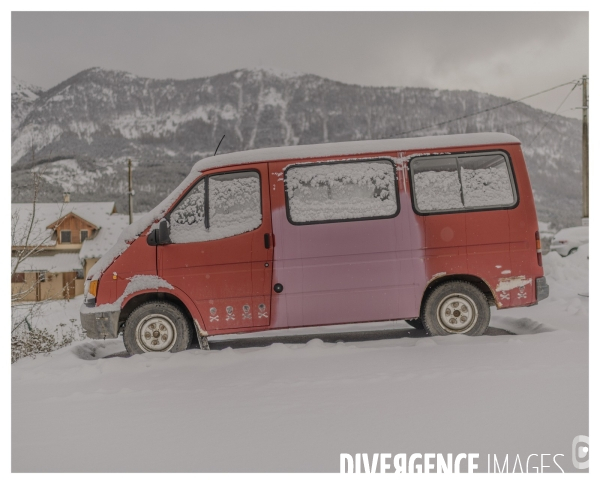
<box><xmin>269</xmin><ymin>159</ymin><xmax>415</xmax><ymax>327</ymax></box>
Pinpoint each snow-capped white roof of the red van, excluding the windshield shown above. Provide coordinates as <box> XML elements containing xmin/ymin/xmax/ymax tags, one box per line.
<box><xmin>194</xmin><ymin>133</ymin><xmax>520</xmax><ymax>171</ymax></box>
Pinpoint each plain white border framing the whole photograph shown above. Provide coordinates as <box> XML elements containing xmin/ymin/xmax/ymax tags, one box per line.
<box><xmin>0</xmin><ymin>0</ymin><xmax>600</xmax><ymax>484</ymax></box>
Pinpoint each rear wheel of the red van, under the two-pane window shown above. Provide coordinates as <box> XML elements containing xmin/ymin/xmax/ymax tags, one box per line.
<box><xmin>420</xmin><ymin>281</ymin><xmax>490</xmax><ymax>336</ymax></box>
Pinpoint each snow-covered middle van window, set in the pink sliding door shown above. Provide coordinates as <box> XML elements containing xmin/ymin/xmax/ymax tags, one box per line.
<box><xmin>285</xmin><ymin>160</ymin><xmax>399</xmax><ymax>224</ymax></box>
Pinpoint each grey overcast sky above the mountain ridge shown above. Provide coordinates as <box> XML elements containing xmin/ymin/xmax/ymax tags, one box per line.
<box><xmin>12</xmin><ymin>12</ymin><xmax>589</xmax><ymax>117</ymax></box>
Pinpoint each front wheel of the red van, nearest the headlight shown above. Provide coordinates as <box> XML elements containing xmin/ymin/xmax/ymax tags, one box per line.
<box><xmin>123</xmin><ymin>301</ymin><xmax>193</xmax><ymax>355</ymax></box>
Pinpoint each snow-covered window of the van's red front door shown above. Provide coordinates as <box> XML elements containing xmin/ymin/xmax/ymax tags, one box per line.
<box><xmin>170</xmin><ymin>171</ymin><xmax>262</xmax><ymax>244</ymax></box>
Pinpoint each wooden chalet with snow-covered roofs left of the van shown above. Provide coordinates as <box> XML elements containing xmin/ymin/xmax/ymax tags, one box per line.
<box><xmin>11</xmin><ymin>196</ymin><xmax>134</xmax><ymax>301</ymax></box>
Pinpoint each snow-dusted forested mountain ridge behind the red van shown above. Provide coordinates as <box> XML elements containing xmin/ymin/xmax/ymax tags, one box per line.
<box><xmin>12</xmin><ymin>68</ymin><xmax>581</xmax><ymax>226</ymax></box>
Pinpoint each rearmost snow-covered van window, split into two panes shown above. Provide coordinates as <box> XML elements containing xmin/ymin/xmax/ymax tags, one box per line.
<box><xmin>410</xmin><ymin>152</ymin><xmax>517</xmax><ymax>213</ymax></box>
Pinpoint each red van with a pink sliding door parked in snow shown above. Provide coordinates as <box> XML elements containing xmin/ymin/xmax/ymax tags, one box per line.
<box><xmin>81</xmin><ymin>133</ymin><xmax>549</xmax><ymax>353</ymax></box>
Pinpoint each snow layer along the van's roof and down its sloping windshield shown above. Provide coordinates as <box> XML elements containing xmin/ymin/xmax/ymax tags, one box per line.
<box><xmin>88</xmin><ymin>133</ymin><xmax>520</xmax><ymax>279</ymax></box>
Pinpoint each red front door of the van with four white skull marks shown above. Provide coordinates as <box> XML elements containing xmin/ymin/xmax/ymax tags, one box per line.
<box><xmin>158</xmin><ymin>163</ymin><xmax>273</xmax><ymax>334</ymax></box>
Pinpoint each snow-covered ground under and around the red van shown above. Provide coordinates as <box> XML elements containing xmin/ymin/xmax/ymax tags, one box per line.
<box><xmin>12</xmin><ymin>246</ymin><xmax>589</xmax><ymax>472</ymax></box>
